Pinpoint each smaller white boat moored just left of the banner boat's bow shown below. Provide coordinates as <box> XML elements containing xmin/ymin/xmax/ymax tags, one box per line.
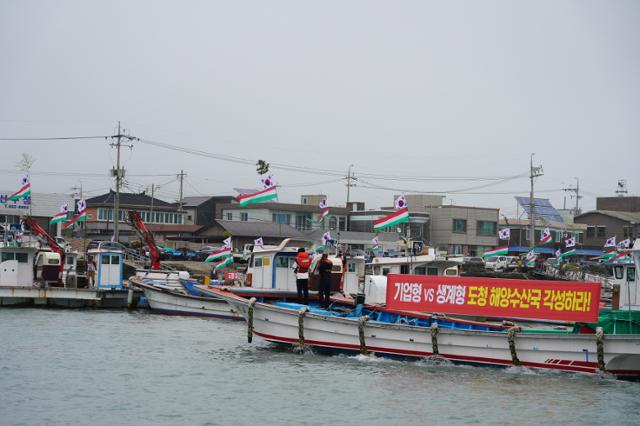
<box><xmin>131</xmin><ymin>277</ymin><xmax>243</xmax><ymax>320</ymax></box>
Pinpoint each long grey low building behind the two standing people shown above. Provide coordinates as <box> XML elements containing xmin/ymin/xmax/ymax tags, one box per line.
<box><xmin>216</xmin><ymin>196</ymin><xmax>349</xmax><ymax>231</ymax></box>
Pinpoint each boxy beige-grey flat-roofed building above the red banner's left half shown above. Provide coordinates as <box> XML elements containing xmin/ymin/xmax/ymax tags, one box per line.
<box><xmin>424</xmin><ymin>201</ymin><xmax>499</xmax><ymax>256</ymax></box>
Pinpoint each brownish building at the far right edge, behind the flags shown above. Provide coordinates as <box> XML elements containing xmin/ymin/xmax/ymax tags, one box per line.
<box><xmin>575</xmin><ymin>210</ymin><xmax>640</xmax><ymax>248</ymax></box>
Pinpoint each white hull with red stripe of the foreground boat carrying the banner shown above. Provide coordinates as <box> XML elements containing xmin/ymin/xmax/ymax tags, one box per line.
<box><xmin>217</xmin><ymin>292</ymin><xmax>640</xmax><ymax>378</ymax></box>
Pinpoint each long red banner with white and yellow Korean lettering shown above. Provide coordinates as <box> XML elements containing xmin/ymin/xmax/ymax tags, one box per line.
<box><xmin>387</xmin><ymin>274</ymin><xmax>600</xmax><ymax>322</ymax></box>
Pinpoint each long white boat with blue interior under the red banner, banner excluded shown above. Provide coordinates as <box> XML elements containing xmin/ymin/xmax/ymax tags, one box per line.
<box><xmin>211</xmin><ymin>240</ymin><xmax>640</xmax><ymax>379</ymax></box>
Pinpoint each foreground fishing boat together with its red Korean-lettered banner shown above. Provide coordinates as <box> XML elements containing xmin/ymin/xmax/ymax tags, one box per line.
<box><xmin>211</xmin><ymin>240</ymin><xmax>640</xmax><ymax>379</ymax></box>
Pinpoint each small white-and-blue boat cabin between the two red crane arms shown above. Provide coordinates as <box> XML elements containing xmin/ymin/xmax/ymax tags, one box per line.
<box><xmin>87</xmin><ymin>241</ymin><xmax>124</xmax><ymax>290</ymax></box>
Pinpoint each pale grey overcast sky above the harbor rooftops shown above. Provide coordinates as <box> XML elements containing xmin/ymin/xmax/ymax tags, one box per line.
<box><xmin>0</xmin><ymin>0</ymin><xmax>640</xmax><ymax>216</ymax></box>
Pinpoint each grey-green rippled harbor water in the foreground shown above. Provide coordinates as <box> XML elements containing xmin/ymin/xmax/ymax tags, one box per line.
<box><xmin>0</xmin><ymin>308</ymin><xmax>640</xmax><ymax>426</ymax></box>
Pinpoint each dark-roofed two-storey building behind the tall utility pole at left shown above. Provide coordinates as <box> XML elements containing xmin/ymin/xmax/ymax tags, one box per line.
<box><xmin>84</xmin><ymin>191</ymin><xmax>186</xmax><ymax>242</ymax></box>
